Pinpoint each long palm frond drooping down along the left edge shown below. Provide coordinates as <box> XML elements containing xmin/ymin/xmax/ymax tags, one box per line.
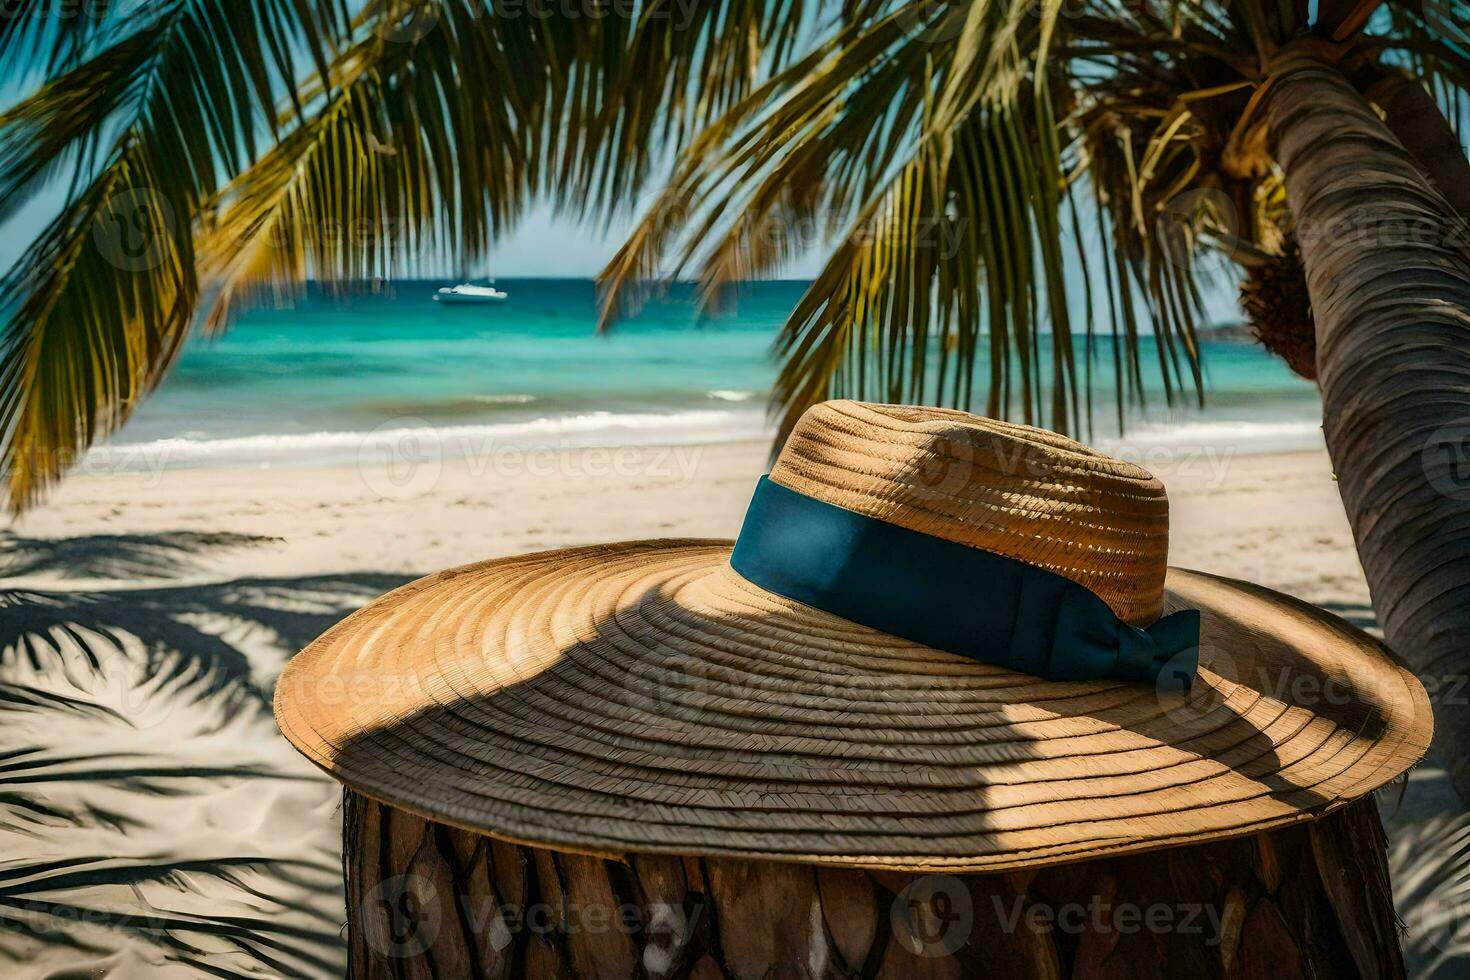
<box><xmin>0</xmin><ymin>0</ymin><xmax>335</xmax><ymax>510</ymax></box>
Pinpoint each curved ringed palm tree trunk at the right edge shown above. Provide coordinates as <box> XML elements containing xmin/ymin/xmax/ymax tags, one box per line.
<box><xmin>1267</xmin><ymin>54</ymin><xmax>1470</xmax><ymax>801</ymax></box>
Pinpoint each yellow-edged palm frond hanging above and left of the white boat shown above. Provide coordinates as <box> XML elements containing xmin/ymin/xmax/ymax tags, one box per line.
<box><xmin>200</xmin><ymin>0</ymin><xmax>579</xmax><ymax>329</ymax></box>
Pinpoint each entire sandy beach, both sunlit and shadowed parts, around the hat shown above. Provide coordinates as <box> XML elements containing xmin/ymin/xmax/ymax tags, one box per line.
<box><xmin>0</xmin><ymin>444</ymin><xmax>1449</xmax><ymax>977</ymax></box>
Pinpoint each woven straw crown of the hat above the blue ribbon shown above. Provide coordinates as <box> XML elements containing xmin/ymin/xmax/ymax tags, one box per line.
<box><xmin>770</xmin><ymin>401</ymin><xmax>1169</xmax><ymax>624</ymax></box>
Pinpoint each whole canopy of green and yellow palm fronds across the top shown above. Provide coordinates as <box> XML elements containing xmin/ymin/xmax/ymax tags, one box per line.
<box><xmin>0</xmin><ymin>0</ymin><xmax>1470</xmax><ymax>508</ymax></box>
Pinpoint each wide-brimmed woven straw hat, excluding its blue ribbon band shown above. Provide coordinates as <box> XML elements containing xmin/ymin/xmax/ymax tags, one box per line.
<box><xmin>276</xmin><ymin>401</ymin><xmax>1430</xmax><ymax>871</ymax></box>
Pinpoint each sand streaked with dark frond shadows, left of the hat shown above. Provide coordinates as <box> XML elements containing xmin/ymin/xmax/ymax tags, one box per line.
<box><xmin>0</xmin><ymin>535</ymin><xmax>404</xmax><ymax>977</ymax></box>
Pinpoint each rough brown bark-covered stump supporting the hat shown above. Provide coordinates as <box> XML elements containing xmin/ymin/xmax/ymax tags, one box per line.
<box><xmin>344</xmin><ymin>790</ymin><xmax>1404</xmax><ymax>980</ymax></box>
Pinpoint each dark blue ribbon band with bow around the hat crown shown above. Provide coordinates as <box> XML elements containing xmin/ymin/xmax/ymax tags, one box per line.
<box><xmin>731</xmin><ymin>478</ymin><xmax>1200</xmax><ymax>691</ymax></box>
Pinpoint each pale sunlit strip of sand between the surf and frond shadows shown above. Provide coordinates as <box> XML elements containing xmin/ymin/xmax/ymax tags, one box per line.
<box><xmin>6</xmin><ymin>442</ymin><xmax>1367</xmax><ymax>608</ymax></box>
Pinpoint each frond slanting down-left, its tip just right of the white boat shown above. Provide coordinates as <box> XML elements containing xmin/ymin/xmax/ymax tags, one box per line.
<box><xmin>600</xmin><ymin>15</ymin><xmax>928</xmax><ymax>321</ymax></box>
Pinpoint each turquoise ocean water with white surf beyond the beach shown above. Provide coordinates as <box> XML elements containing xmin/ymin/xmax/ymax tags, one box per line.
<box><xmin>94</xmin><ymin>279</ymin><xmax>1320</xmax><ymax>466</ymax></box>
